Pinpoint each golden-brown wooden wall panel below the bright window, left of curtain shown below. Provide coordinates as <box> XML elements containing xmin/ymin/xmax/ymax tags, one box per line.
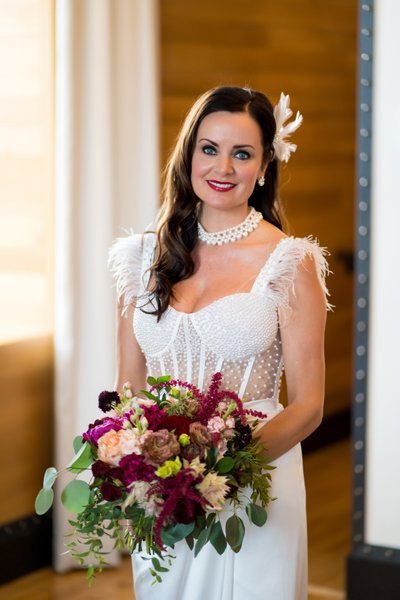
<box><xmin>0</xmin><ymin>338</ymin><xmax>54</xmax><ymax>525</ymax></box>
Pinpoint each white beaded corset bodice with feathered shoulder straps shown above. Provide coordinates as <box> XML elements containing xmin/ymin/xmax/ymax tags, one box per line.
<box><xmin>110</xmin><ymin>234</ymin><xmax>327</xmax><ymax>404</ymax></box>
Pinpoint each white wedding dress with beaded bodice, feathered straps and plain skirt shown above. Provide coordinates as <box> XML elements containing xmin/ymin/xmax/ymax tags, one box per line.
<box><xmin>110</xmin><ymin>234</ymin><xmax>327</xmax><ymax>600</ymax></box>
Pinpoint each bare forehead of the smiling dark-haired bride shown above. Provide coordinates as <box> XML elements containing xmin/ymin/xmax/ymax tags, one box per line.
<box><xmin>197</xmin><ymin>111</ymin><xmax>262</xmax><ymax>145</ymax></box>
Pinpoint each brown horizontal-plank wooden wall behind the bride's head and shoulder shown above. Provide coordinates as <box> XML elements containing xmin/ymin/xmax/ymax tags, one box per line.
<box><xmin>160</xmin><ymin>0</ymin><xmax>357</xmax><ymax>414</ymax></box>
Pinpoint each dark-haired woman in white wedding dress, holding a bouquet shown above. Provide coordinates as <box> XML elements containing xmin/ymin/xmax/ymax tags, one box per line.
<box><xmin>111</xmin><ymin>87</ymin><xmax>328</xmax><ymax>600</ymax></box>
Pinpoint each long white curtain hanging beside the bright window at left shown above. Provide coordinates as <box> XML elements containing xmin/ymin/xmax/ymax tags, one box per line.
<box><xmin>54</xmin><ymin>0</ymin><xmax>159</xmax><ymax>571</ymax></box>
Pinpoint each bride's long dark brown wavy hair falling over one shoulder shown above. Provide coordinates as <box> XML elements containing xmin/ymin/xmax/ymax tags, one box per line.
<box><xmin>146</xmin><ymin>86</ymin><xmax>283</xmax><ymax>320</ymax></box>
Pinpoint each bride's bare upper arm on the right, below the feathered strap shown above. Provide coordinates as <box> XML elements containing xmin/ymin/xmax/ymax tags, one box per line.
<box><xmin>280</xmin><ymin>255</ymin><xmax>326</xmax><ymax>417</ymax></box>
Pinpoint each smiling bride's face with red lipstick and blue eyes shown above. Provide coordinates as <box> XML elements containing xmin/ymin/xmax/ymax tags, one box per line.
<box><xmin>191</xmin><ymin>111</ymin><xmax>265</xmax><ymax>209</ymax></box>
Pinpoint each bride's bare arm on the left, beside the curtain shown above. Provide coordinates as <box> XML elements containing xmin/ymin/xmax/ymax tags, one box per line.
<box><xmin>115</xmin><ymin>303</ymin><xmax>146</xmax><ymax>392</ymax></box>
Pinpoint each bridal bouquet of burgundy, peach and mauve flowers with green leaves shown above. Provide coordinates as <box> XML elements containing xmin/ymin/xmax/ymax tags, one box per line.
<box><xmin>35</xmin><ymin>373</ymin><xmax>272</xmax><ymax>581</ymax></box>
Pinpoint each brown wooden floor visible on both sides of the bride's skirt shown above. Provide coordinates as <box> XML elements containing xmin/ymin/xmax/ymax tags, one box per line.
<box><xmin>0</xmin><ymin>441</ymin><xmax>351</xmax><ymax>600</ymax></box>
